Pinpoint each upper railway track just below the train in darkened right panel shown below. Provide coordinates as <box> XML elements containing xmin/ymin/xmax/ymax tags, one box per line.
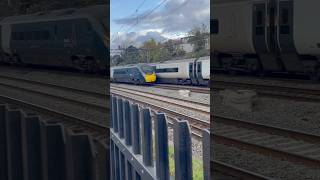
<box><xmin>212</xmin><ymin>79</ymin><xmax>320</xmax><ymax>102</ymax></box>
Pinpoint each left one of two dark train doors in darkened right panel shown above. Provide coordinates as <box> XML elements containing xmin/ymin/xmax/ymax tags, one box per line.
<box><xmin>252</xmin><ymin>0</ymin><xmax>281</xmax><ymax>72</ymax></box>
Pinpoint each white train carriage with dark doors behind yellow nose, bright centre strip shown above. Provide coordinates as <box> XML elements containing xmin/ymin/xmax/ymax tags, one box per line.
<box><xmin>151</xmin><ymin>57</ymin><xmax>210</xmax><ymax>85</ymax></box>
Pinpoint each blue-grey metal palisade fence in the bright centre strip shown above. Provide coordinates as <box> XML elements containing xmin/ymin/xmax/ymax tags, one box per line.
<box><xmin>110</xmin><ymin>96</ymin><xmax>210</xmax><ymax>180</ymax></box>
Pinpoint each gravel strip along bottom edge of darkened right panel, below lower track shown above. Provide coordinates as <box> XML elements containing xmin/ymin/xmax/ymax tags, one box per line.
<box><xmin>211</xmin><ymin>144</ymin><xmax>320</xmax><ymax>180</ymax></box>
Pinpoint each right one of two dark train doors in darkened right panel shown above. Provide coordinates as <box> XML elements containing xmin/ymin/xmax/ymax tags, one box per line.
<box><xmin>277</xmin><ymin>0</ymin><xmax>303</xmax><ymax>72</ymax></box>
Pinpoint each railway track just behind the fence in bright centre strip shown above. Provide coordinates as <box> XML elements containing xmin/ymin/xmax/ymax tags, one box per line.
<box><xmin>110</xmin><ymin>86</ymin><xmax>210</xmax><ymax>139</ymax></box>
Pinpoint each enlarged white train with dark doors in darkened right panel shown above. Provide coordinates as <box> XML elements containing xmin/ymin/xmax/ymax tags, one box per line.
<box><xmin>210</xmin><ymin>0</ymin><xmax>320</xmax><ymax>80</ymax></box>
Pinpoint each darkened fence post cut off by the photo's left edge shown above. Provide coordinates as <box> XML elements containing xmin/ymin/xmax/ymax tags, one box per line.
<box><xmin>0</xmin><ymin>104</ymin><xmax>8</xmax><ymax>179</ymax></box>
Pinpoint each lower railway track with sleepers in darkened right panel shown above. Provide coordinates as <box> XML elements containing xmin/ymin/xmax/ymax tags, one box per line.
<box><xmin>211</xmin><ymin>116</ymin><xmax>320</xmax><ymax>168</ymax></box>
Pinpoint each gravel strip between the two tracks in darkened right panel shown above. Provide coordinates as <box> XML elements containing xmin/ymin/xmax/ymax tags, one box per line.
<box><xmin>213</xmin><ymin>92</ymin><xmax>320</xmax><ymax>135</ymax></box>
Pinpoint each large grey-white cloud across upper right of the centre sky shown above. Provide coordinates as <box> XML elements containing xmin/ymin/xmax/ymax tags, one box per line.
<box><xmin>114</xmin><ymin>0</ymin><xmax>210</xmax><ymax>32</ymax></box>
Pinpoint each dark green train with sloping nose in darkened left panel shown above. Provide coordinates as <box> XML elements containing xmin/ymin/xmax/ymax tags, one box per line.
<box><xmin>0</xmin><ymin>5</ymin><xmax>110</xmax><ymax>72</ymax></box>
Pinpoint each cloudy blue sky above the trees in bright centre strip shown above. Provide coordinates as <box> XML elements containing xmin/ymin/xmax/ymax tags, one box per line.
<box><xmin>110</xmin><ymin>0</ymin><xmax>210</xmax><ymax>48</ymax></box>
